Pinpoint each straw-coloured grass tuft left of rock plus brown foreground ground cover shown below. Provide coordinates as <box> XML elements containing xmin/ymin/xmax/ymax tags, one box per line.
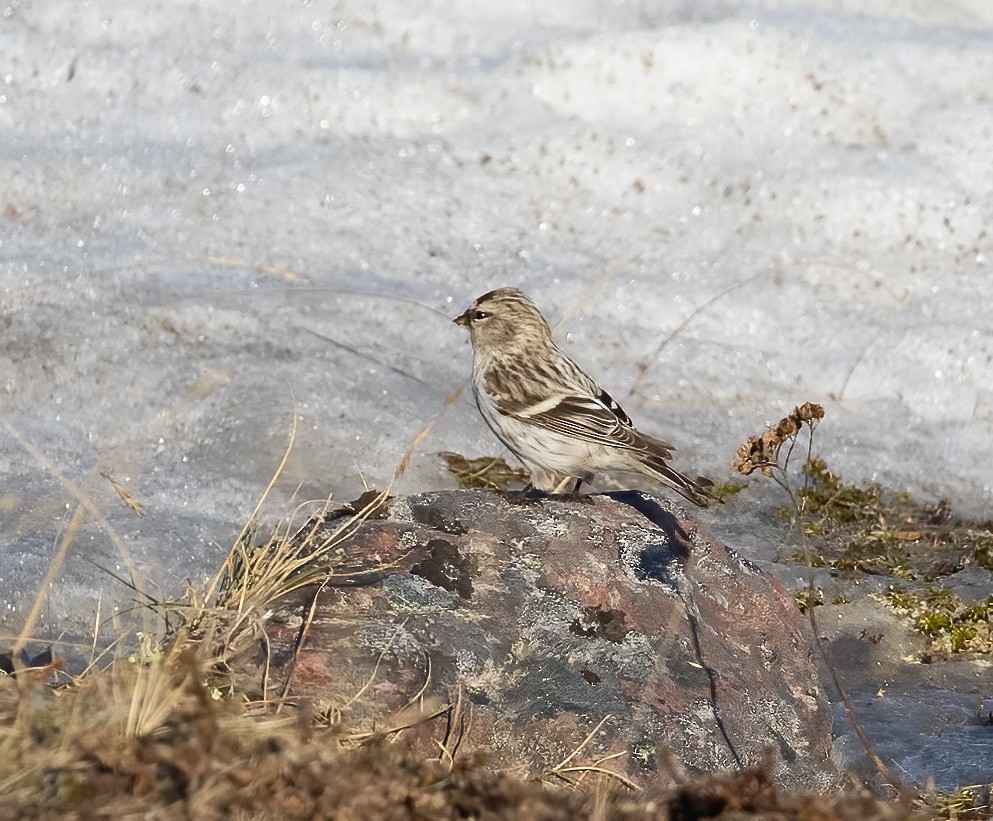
<box><xmin>0</xmin><ymin>414</ymin><xmax>972</xmax><ymax>821</ymax></box>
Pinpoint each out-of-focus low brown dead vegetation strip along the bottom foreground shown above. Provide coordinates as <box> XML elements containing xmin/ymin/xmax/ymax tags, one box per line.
<box><xmin>0</xmin><ymin>648</ymin><xmax>925</xmax><ymax>821</ymax></box>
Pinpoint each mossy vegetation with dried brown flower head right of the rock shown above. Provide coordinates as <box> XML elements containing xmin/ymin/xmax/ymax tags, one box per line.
<box><xmin>732</xmin><ymin>402</ymin><xmax>993</xmax><ymax>819</ymax></box>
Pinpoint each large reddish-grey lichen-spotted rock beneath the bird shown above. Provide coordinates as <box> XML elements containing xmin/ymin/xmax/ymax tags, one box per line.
<box><xmin>258</xmin><ymin>492</ymin><xmax>834</xmax><ymax>789</ymax></box>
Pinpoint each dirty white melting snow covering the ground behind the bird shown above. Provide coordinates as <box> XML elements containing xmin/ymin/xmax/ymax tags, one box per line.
<box><xmin>0</xmin><ymin>0</ymin><xmax>993</xmax><ymax>788</ymax></box>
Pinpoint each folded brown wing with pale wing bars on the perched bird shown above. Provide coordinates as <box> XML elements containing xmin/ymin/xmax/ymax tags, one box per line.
<box><xmin>492</xmin><ymin>359</ymin><xmax>672</xmax><ymax>459</ymax></box>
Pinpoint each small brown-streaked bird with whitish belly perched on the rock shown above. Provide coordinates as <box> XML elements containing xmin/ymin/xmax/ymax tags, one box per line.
<box><xmin>454</xmin><ymin>288</ymin><xmax>714</xmax><ymax>507</ymax></box>
